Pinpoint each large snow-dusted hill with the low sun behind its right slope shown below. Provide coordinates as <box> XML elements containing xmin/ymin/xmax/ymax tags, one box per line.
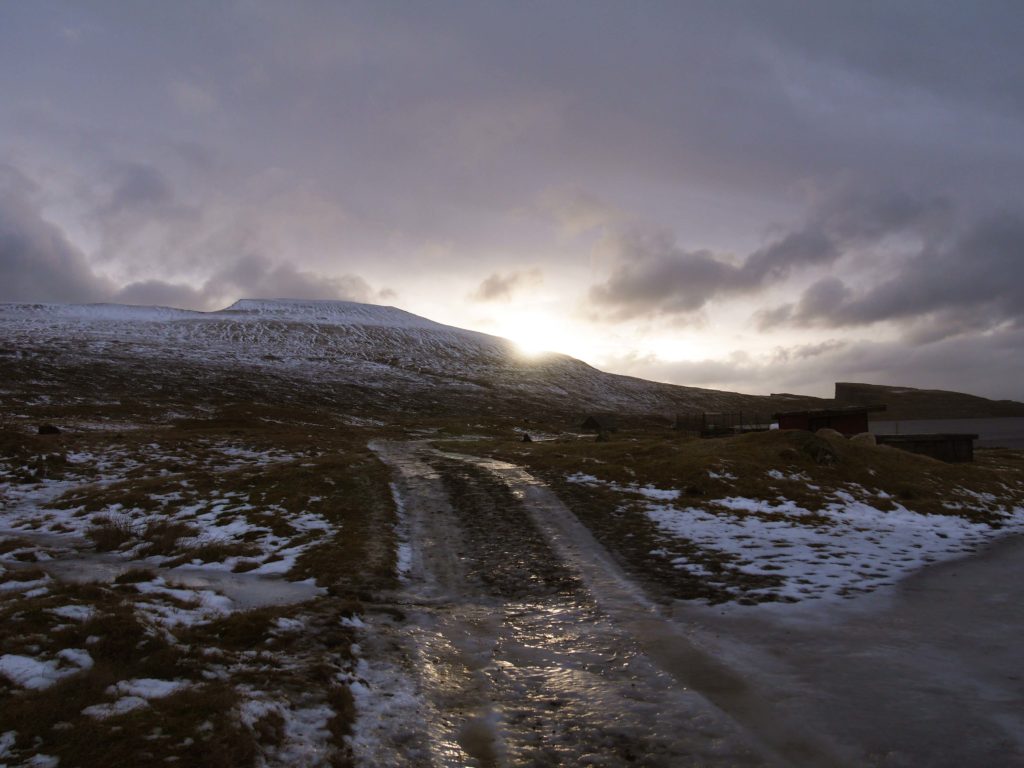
<box><xmin>0</xmin><ymin>299</ymin><xmax>794</xmax><ymax>416</ymax></box>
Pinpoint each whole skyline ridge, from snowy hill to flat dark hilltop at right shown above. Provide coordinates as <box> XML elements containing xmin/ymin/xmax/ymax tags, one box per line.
<box><xmin>0</xmin><ymin>299</ymin><xmax>1024</xmax><ymax>428</ymax></box>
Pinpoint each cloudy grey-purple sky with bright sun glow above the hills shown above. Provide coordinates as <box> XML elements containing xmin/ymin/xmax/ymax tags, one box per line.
<box><xmin>0</xmin><ymin>0</ymin><xmax>1024</xmax><ymax>400</ymax></box>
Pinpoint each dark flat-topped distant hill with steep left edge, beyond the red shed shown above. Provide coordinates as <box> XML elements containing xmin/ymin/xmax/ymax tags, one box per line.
<box><xmin>836</xmin><ymin>381</ymin><xmax>1024</xmax><ymax>421</ymax></box>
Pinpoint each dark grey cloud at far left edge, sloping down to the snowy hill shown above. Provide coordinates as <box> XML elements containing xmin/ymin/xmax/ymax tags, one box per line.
<box><xmin>0</xmin><ymin>165</ymin><xmax>111</xmax><ymax>302</ymax></box>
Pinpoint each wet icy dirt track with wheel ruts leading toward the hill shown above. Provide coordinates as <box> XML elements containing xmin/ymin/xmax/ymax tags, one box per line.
<box><xmin>367</xmin><ymin>443</ymin><xmax>845</xmax><ymax>766</ymax></box>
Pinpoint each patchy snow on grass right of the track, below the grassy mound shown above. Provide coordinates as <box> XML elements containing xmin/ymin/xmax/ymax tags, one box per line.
<box><xmin>566</xmin><ymin>470</ymin><xmax>1024</xmax><ymax>602</ymax></box>
